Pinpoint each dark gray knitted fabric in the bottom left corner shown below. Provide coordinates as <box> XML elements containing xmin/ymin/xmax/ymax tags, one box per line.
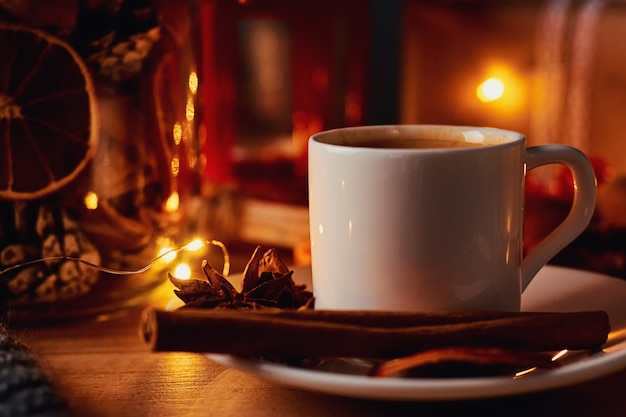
<box><xmin>0</xmin><ymin>325</ymin><xmax>68</xmax><ymax>417</ymax></box>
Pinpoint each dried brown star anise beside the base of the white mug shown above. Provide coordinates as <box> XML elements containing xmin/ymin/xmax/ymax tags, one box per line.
<box><xmin>169</xmin><ymin>246</ymin><xmax>313</xmax><ymax>309</ymax></box>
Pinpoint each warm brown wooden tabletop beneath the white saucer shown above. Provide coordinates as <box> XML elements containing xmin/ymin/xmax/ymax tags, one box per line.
<box><xmin>23</xmin><ymin>278</ymin><xmax>626</xmax><ymax>417</ymax></box>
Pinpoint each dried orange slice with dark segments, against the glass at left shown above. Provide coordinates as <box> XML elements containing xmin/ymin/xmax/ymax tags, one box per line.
<box><xmin>0</xmin><ymin>24</ymin><xmax>98</xmax><ymax>200</ymax></box>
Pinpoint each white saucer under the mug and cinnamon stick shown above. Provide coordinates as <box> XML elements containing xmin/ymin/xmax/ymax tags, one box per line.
<box><xmin>207</xmin><ymin>266</ymin><xmax>626</xmax><ymax>400</ymax></box>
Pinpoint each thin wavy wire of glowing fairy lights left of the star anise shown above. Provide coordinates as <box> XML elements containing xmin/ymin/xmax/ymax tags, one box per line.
<box><xmin>0</xmin><ymin>240</ymin><xmax>230</xmax><ymax>278</ymax></box>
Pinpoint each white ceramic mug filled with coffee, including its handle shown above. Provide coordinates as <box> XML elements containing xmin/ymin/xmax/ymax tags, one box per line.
<box><xmin>309</xmin><ymin>125</ymin><xmax>596</xmax><ymax>311</ymax></box>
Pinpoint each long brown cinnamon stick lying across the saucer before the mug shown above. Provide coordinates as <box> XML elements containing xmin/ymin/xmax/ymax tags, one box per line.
<box><xmin>140</xmin><ymin>308</ymin><xmax>610</xmax><ymax>358</ymax></box>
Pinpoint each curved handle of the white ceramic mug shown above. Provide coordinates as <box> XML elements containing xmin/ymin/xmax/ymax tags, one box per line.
<box><xmin>522</xmin><ymin>145</ymin><xmax>596</xmax><ymax>291</ymax></box>
